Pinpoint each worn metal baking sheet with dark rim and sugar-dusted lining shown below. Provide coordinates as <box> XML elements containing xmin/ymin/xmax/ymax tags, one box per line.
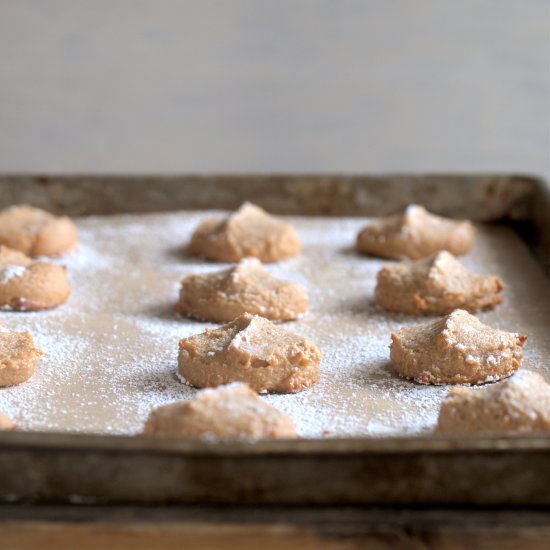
<box><xmin>0</xmin><ymin>175</ymin><xmax>550</xmax><ymax>504</ymax></box>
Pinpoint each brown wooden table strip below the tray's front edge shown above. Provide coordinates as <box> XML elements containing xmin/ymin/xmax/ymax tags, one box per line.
<box><xmin>0</xmin><ymin>506</ymin><xmax>550</xmax><ymax>550</ymax></box>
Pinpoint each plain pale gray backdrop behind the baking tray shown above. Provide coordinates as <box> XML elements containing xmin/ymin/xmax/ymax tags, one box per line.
<box><xmin>0</xmin><ymin>0</ymin><xmax>550</xmax><ymax>177</ymax></box>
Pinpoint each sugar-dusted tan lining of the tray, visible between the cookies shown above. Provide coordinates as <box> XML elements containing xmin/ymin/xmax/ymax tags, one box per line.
<box><xmin>0</xmin><ymin>212</ymin><xmax>550</xmax><ymax>437</ymax></box>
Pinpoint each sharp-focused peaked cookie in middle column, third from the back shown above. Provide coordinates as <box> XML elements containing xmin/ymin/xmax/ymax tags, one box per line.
<box><xmin>178</xmin><ymin>313</ymin><xmax>321</xmax><ymax>393</ymax></box>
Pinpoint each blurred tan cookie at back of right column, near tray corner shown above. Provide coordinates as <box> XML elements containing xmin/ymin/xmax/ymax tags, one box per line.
<box><xmin>357</xmin><ymin>204</ymin><xmax>475</xmax><ymax>260</ymax></box>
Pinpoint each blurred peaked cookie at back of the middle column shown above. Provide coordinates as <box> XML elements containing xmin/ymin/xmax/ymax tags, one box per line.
<box><xmin>188</xmin><ymin>202</ymin><xmax>301</xmax><ymax>263</ymax></box>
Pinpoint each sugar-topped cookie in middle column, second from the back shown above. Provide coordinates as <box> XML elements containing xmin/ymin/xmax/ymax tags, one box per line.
<box><xmin>175</xmin><ymin>258</ymin><xmax>308</xmax><ymax>323</ymax></box>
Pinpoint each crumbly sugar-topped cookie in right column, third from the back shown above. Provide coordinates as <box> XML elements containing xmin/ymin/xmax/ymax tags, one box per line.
<box><xmin>390</xmin><ymin>309</ymin><xmax>526</xmax><ymax>384</ymax></box>
